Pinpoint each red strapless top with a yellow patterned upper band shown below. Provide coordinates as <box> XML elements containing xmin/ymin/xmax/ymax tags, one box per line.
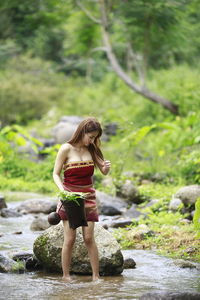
<box><xmin>63</xmin><ymin>160</ymin><xmax>94</xmax><ymax>186</ymax></box>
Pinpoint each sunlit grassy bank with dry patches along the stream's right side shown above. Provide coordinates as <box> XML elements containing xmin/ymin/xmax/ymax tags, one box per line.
<box><xmin>114</xmin><ymin>184</ymin><xmax>200</xmax><ymax>262</ymax></box>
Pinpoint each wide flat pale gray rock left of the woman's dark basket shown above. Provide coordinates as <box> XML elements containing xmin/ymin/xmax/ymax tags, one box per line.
<box><xmin>16</xmin><ymin>199</ymin><xmax>57</xmax><ymax>214</ymax></box>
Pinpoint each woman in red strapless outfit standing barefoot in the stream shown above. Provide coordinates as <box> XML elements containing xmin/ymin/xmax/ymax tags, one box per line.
<box><xmin>53</xmin><ymin>118</ymin><xmax>111</xmax><ymax>282</ymax></box>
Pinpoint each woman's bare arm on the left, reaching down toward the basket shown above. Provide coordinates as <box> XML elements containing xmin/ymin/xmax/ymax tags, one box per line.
<box><xmin>53</xmin><ymin>144</ymin><xmax>70</xmax><ymax>191</ymax></box>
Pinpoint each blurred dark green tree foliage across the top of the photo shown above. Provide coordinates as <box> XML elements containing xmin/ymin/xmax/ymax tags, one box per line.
<box><xmin>0</xmin><ymin>0</ymin><xmax>200</xmax><ymax>78</ymax></box>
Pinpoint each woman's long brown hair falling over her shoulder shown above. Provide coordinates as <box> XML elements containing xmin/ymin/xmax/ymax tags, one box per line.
<box><xmin>68</xmin><ymin>118</ymin><xmax>104</xmax><ymax>166</ymax></box>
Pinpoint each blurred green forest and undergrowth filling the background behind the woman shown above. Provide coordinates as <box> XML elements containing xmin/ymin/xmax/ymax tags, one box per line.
<box><xmin>0</xmin><ymin>0</ymin><xmax>200</xmax><ymax>260</ymax></box>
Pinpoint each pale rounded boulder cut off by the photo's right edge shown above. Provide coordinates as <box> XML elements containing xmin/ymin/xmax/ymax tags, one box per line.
<box><xmin>174</xmin><ymin>185</ymin><xmax>200</xmax><ymax>205</ymax></box>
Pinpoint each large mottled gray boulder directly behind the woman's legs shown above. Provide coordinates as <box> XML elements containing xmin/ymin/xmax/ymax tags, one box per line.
<box><xmin>33</xmin><ymin>223</ymin><xmax>124</xmax><ymax>275</ymax></box>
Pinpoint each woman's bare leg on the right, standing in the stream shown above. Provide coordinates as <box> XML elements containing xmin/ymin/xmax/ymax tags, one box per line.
<box><xmin>82</xmin><ymin>222</ymin><xmax>99</xmax><ymax>280</ymax></box>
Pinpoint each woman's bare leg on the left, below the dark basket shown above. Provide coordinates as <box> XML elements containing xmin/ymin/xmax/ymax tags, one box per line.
<box><xmin>62</xmin><ymin>221</ymin><xmax>76</xmax><ymax>282</ymax></box>
